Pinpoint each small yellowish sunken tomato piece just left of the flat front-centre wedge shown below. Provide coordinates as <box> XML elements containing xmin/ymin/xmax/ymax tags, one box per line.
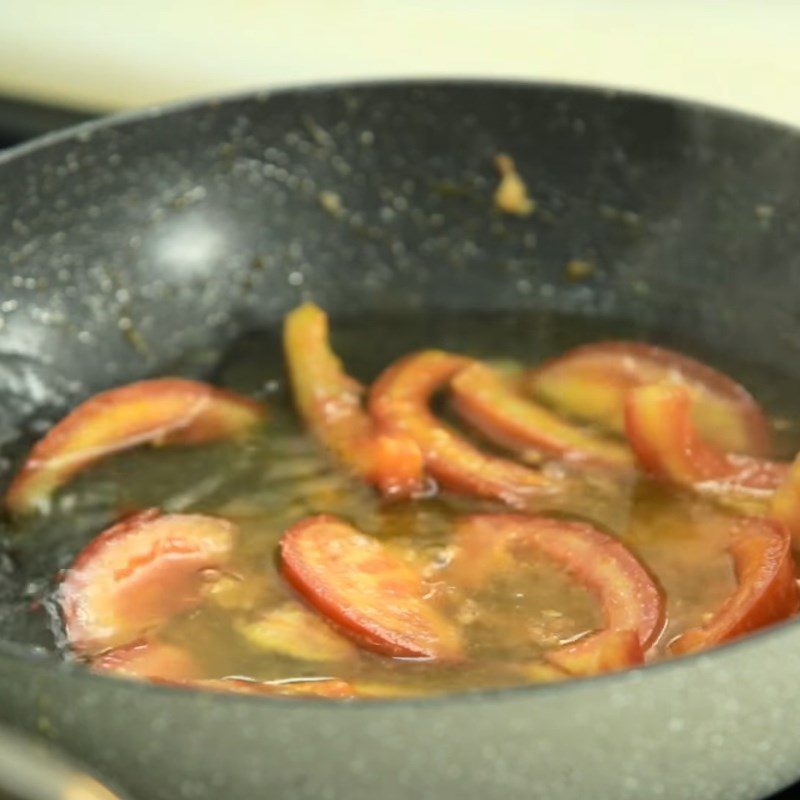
<box><xmin>236</xmin><ymin>601</ymin><xmax>355</xmax><ymax>661</ymax></box>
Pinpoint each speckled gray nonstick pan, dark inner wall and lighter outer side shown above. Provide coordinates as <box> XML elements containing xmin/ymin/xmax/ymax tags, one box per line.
<box><xmin>0</xmin><ymin>83</ymin><xmax>800</xmax><ymax>800</ymax></box>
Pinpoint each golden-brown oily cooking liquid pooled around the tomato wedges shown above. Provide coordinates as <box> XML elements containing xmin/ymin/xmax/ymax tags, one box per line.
<box><xmin>9</xmin><ymin>310</ymin><xmax>796</xmax><ymax>696</ymax></box>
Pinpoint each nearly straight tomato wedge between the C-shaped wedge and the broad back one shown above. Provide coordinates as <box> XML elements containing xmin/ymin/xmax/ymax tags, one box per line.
<box><xmin>450</xmin><ymin>363</ymin><xmax>633</xmax><ymax>468</ymax></box>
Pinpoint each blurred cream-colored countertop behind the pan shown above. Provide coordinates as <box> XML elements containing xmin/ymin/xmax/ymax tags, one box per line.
<box><xmin>0</xmin><ymin>0</ymin><xmax>800</xmax><ymax>125</ymax></box>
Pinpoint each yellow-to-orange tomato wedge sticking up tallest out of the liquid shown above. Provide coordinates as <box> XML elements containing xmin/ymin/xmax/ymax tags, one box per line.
<box><xmin>284</xmin><ymin>303</ymin><xmax>425</xmax><ymax>498</ymax></box>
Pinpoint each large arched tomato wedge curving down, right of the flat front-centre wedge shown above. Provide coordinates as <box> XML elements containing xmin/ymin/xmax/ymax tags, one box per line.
<box><xmin>453</xmin><ymin>514</ymin><xmax>664</xmax><ymax>650</ymax></box>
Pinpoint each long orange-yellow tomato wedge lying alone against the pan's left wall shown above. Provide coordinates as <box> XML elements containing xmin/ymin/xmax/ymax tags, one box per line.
<box><xmin>5</xmin><ymin>378</ymin><xmax>264</xmax><ymax>514</ymax></box>
